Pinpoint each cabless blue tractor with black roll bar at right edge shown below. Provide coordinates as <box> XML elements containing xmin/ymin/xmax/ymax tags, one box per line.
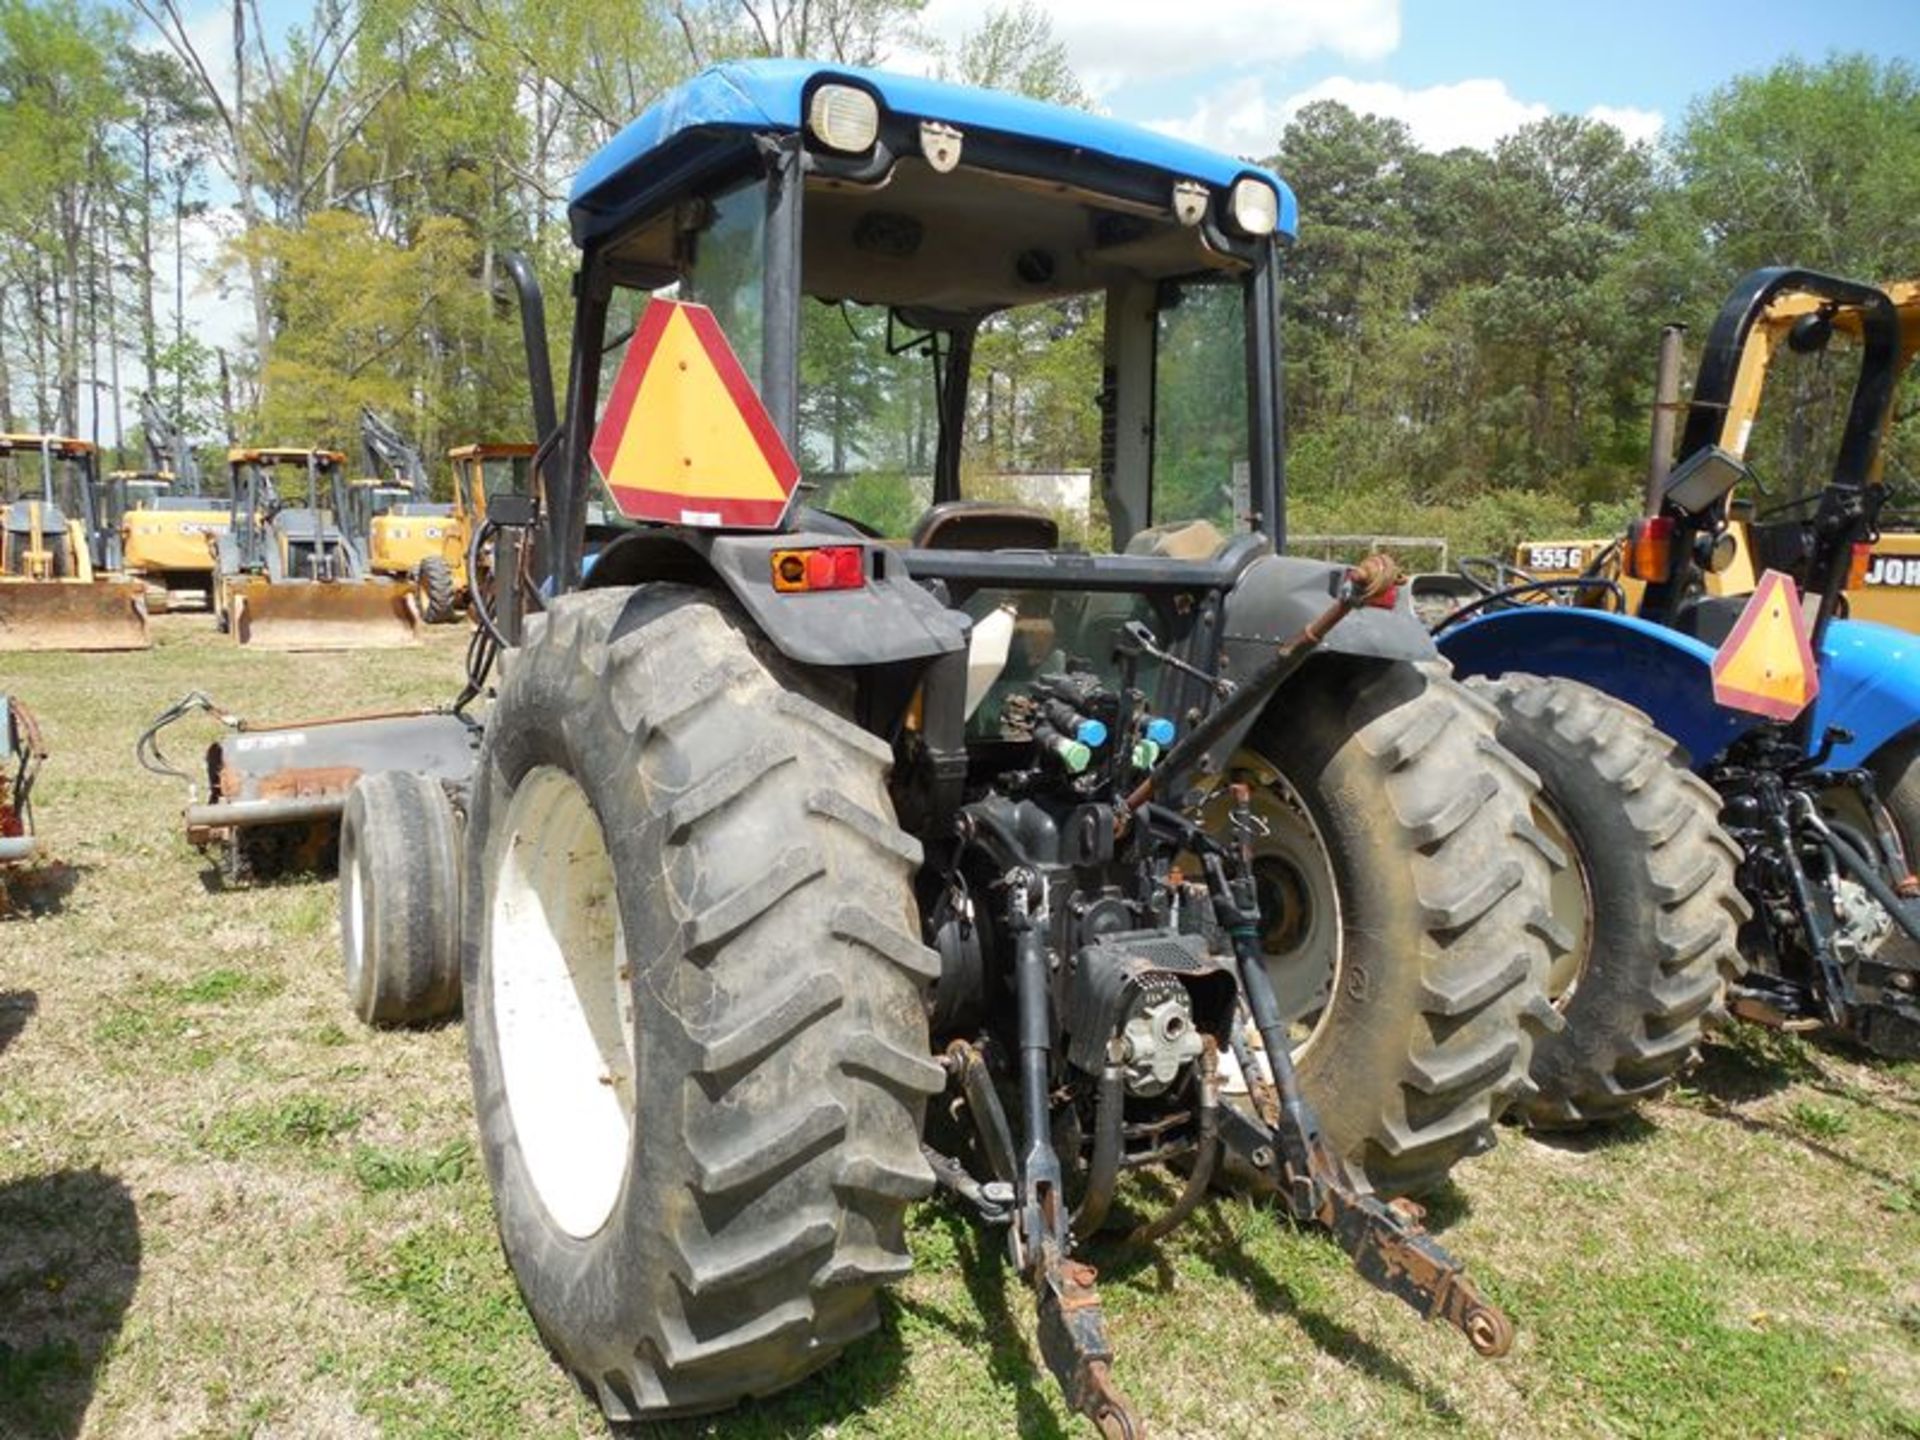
<box><xmin>1438</xmin><ymin>269</ymin><xmax>1920</xmax><ymax>1090</ymax></box>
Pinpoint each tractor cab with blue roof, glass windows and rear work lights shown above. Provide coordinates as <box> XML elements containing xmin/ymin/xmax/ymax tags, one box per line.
<box><xmin>568</xmin><ymin>63</ymin><xmax>1294</xmax><ymax>576</ymax></box>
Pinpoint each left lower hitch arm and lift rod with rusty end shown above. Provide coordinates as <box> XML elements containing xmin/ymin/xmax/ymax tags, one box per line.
<box><xmin>1006</xmin><ymin>868</ymin><xmax>1144</xmax><ymax>1440</ymax></box>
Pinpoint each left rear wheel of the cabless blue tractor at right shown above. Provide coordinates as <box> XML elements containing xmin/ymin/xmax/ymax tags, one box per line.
<box><xmin>1471</xmin><ymin>676</ymin><xmax>1749</xmax><ymax>1129</ymax></box>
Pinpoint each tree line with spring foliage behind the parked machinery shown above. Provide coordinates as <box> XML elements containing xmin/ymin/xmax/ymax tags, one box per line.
<box><xmin>0</xmin><ymin>0</ymin><xmax>1920</xmax><ymax>545</ymax></box>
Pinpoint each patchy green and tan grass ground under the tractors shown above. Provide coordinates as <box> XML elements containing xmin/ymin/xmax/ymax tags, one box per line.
<box><xmin>0</xmin><ymin>616</ymin><xmax>1920</xmax><ymax>1440</ymax></box>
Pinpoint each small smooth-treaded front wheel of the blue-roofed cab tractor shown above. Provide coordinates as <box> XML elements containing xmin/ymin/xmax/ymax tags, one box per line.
<box><xmin>340</xmin><ymin>770</ymin><xmax>461</xmax><ymax>1027</ymax></box>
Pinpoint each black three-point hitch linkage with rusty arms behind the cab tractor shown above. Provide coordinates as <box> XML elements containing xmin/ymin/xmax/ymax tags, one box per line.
<box><xmin>927</xmin><ymin>557</ymin><xmax>1513</xmax><ymax>1440</ymax></box>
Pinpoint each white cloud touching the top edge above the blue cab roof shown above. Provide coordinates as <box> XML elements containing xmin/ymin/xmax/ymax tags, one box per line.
<box><xmin>922</xmin><ymin>0</ymin><xmax>1400</xmax><ymax>94</ymax></box>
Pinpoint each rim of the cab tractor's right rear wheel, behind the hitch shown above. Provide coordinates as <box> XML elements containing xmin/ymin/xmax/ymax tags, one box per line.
<box><xmin>1206</xmin><ymin>749</ymin><xmax>1344</xmax><ymax>1064</ymax></box>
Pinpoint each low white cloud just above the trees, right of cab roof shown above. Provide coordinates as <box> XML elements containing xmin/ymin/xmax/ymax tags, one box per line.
<box><xmin>1150</xmin><ymin>75</ymin><xmax>1661</xmax><ymax>156</ymax></box>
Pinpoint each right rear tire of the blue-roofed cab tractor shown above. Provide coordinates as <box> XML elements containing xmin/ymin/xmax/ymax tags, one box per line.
<box><xmin>1231</xmin><ymin>655</ymin><xmax>1561</xmax><ymax>1194</ymax></box>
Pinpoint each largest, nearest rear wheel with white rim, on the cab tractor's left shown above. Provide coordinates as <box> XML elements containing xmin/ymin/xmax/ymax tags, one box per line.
<box><xmin>463</xmin><ymin>584</ymin><xmax>943</xmax><ymax>1421</ymax></box>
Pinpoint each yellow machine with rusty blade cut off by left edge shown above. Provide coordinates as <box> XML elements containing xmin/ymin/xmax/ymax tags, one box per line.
<box><xmin>0</xmin><ymin>434</ymin><xmax>154</xmax><ymax>651</ymax></box>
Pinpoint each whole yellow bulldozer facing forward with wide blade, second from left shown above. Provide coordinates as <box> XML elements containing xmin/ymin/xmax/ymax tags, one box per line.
<box><xmin>215</xmin><ymin>445</ymin><xmax>420</xmax><ymax>651</ymax></box>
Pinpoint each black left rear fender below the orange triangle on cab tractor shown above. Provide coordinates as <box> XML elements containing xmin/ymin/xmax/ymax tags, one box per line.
<box><xmin>584</xmin><ymin>526</ymin><xmax>972</xmax><ymax>668</ymax></box>
